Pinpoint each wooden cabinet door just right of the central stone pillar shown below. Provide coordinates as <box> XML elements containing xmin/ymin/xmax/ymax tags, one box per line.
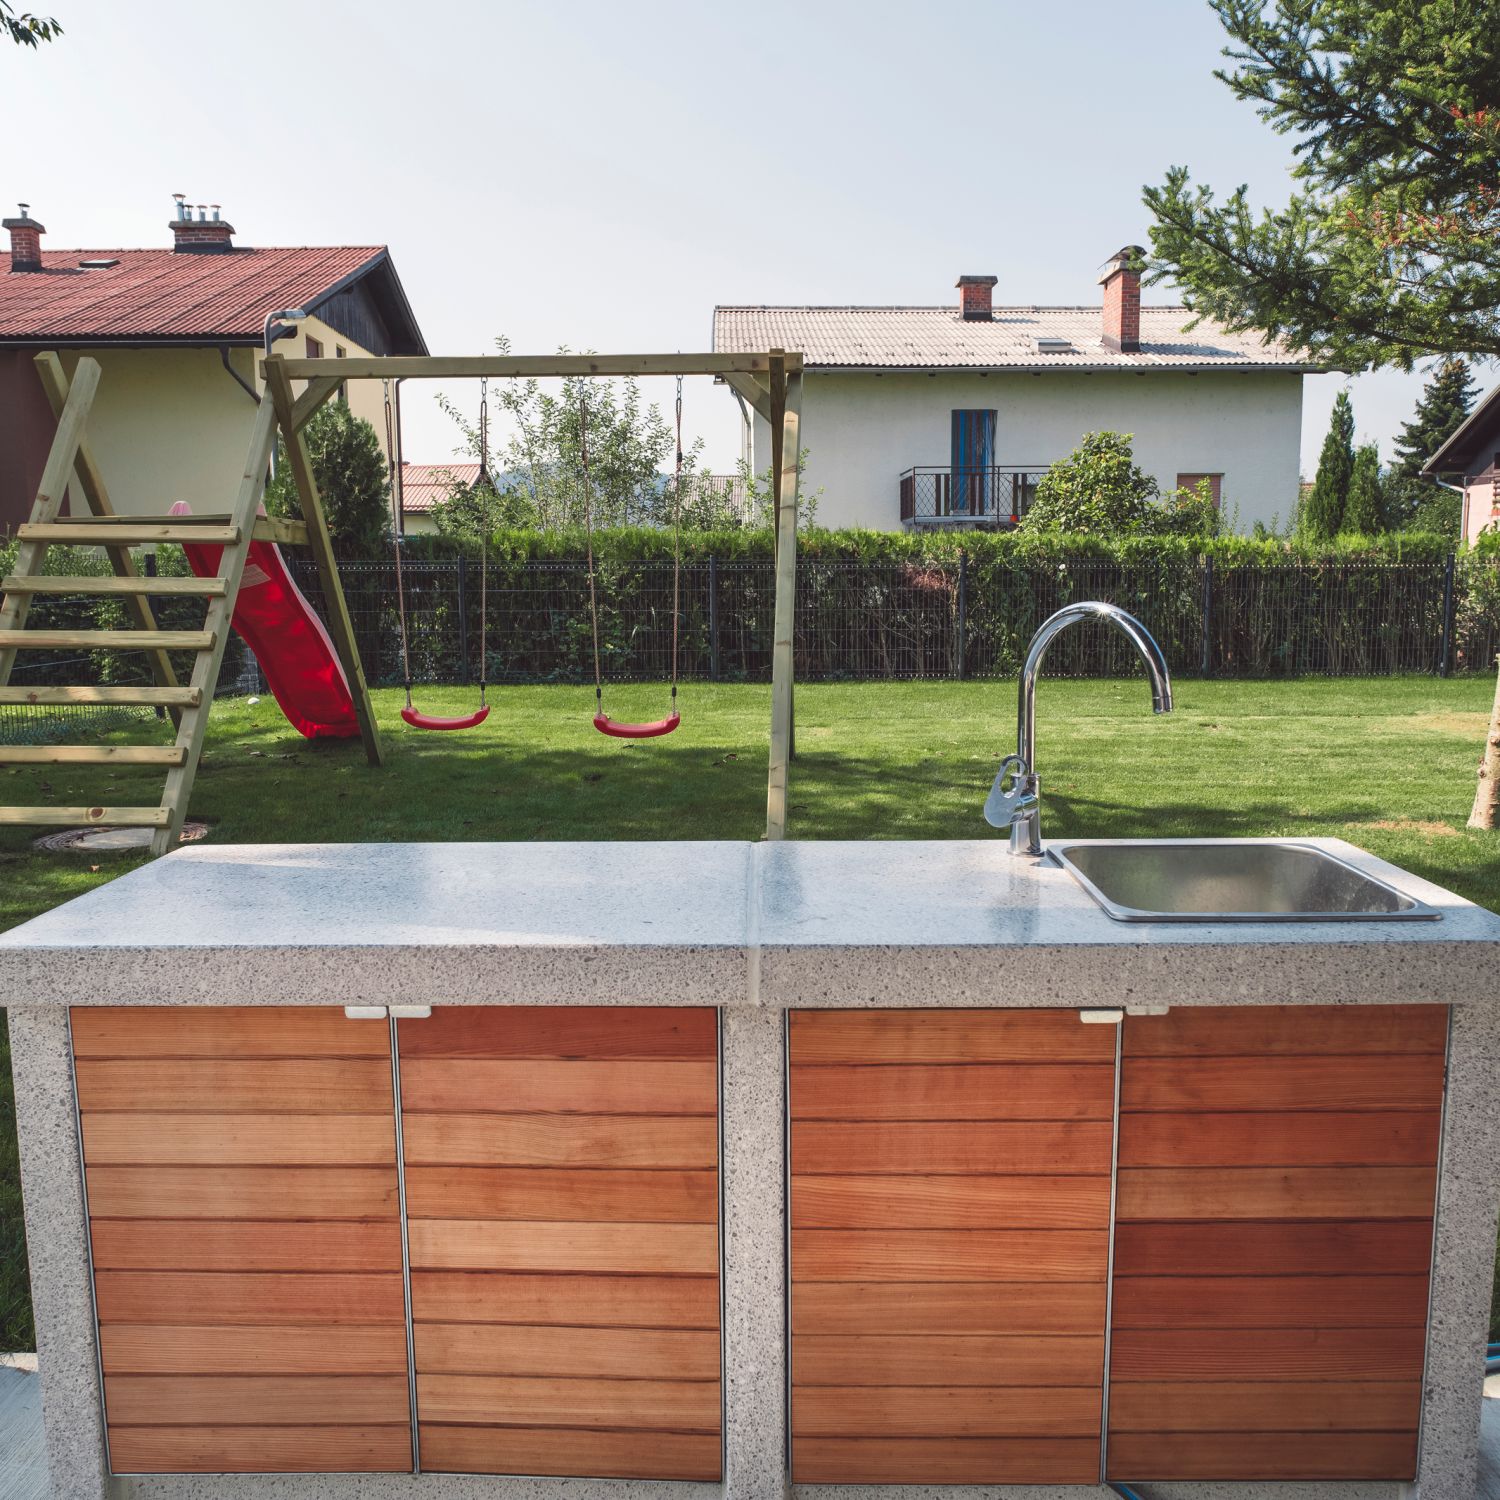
<box><xmin>789</xmin><ymin>1010</ymin><xmax>1116</xmax><ymax>1485</ymax></box>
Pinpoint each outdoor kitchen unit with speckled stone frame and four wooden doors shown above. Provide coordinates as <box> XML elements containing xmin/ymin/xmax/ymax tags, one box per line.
<box><xmin>0</xmin><ymin>839</ymin><xmax>1500</xmax><ymax>1500</ymax></box>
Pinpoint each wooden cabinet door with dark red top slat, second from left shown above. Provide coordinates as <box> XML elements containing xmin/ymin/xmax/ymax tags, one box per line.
<box><xmin>399</xmin><ymin>1007</ymin><xmax>722</xmax><ymax>1481</ymax></box>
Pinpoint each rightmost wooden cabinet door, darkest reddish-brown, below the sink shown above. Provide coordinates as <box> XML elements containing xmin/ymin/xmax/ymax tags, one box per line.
<box><xmin>1109</xmin><ymin>1005</ymin><xmax>1448</xmax><ymax>1482</ymax></box>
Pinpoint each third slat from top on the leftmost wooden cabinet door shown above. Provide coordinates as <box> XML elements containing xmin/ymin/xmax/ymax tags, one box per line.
<box><xmin>83</xmin><ymin>1112</ymin><xmax>396</xmax><ymax>1167</ymax></box>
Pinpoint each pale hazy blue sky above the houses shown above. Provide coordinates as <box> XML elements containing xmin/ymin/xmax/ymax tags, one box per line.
<box><xmin>0</xmin><ymin>0</ymin><xmax>1494</xmax><ymax>476</ymax></box>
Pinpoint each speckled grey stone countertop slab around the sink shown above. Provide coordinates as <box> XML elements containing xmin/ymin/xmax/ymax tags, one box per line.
<box><xmin>0</xmin><ymin>839</ymin><xmax>1500</xmax><ymax>1007</ymax></box>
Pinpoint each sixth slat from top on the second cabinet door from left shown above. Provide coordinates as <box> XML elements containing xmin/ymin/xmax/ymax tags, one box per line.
<box><xmin>398</xmin><ymin>1271</ymin><xmax>719</xmax><ymax>1329</ymax></box>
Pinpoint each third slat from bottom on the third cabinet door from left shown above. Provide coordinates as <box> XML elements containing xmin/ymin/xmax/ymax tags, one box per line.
<box><xmin>792</xmin><ymin>1332</ymin><xmax>1104</xmax><ymax>1388</ymax></box>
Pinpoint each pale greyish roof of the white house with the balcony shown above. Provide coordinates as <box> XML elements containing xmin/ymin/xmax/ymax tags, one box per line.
<box><xmin>714</xmin><ymin>306</ymin><xmax>1320</xmax><ymax>371</ymax></box>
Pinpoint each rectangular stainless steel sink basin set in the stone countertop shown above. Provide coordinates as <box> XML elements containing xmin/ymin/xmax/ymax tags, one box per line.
<box><xmin>1047</xmin><ymin>839</ymin><xmax>1442</xmax><ymax>923</ymax></box>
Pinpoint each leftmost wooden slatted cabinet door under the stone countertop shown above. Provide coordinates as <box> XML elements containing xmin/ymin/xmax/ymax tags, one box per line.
<box><xmin>72</xmin><ymin>1007</ymin><xmax>413</xmax><ymax>1473</ymax></box>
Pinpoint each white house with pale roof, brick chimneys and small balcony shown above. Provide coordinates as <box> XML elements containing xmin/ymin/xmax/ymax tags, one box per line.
<box><xmin>714</xmin><ymin>246</ymin><xmax>1319</xmax><ymax>531</ymax></box>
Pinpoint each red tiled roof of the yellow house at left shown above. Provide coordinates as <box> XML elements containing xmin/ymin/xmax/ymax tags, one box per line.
<box><xmin>0</xmin><ymin>245</ymin><xmax>386</xmax><ymax>344</ymax></box>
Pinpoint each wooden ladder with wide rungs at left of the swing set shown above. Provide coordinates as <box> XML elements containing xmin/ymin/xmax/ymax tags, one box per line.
<box><xmin>0</xmin><ymin>354</ymin><xmax>285</xmax><ymax>854</ymax></box>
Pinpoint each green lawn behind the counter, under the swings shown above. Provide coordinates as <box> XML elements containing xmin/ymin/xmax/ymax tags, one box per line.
<box><xmin>0</xmin><ymin>678</ymin><xmax>1500</xmax><ymax>1349</ymax></box>
